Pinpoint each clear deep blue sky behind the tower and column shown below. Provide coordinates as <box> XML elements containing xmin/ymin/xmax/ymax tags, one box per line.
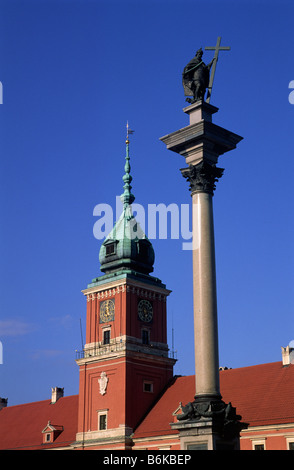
<box><xmin>0</xmin><ymin>0</ymin><xmax>294</xmax><ymax>405</ymax></box>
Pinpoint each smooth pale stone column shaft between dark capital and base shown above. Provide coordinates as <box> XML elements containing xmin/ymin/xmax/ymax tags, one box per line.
<box><xmin>192</xmin><ymin>192</ymin><xmax>220</xmax><ymax>398</ymax></box>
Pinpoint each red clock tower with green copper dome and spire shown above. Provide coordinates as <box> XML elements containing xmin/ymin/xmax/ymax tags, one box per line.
<box><xmin>74</xmin><ymin>131</ymin><xmax>175</xmax><ymax>449</ymax></box>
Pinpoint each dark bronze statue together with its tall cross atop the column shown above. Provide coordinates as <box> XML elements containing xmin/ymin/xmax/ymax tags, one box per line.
<box><xmin>182</xmin><ymin>37</ymin><xmax>231</xmax><ymax>104</ymax></box>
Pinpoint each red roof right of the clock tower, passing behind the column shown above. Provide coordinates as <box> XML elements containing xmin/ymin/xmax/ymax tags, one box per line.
<box><xmin>134</xmin><ymin>362</ymin><xmax>294</xmax><ymax>439</ymax></box>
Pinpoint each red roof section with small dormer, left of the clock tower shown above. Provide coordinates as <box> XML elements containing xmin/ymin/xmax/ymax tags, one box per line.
<box><xmin>0</xmin><ymin>395</ymin><xmax>79</xmax><ymax>449</ymax></box>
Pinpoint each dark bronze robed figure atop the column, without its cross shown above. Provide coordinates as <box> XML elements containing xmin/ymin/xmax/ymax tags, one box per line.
<box><xmin>183</xmin><ymin>48</ymin><xmax>215</xmax><ymax>104</ymax></box>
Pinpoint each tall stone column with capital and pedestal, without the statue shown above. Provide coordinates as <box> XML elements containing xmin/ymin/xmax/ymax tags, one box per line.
<box><xmin>161</xmin><ymin>101</ymin><xmax>244</xmax><ymax>449</ymax></box>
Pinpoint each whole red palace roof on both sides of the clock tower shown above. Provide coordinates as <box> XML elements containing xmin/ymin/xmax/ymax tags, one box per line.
<box><xmin>0</xmin><ymin>362</ymin><xmax>294</xmax><ymax>449</ymax></box>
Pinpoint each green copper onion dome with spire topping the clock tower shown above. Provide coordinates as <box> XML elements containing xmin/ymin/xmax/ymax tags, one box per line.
<box><xmin>99</xmin><ymin>132</ymin><xmax>154</xmax><ymax>274</ymax></box>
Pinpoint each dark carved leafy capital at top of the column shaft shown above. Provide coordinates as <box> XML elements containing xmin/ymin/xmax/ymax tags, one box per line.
<box><xmin>181</xmin><ymin>160</ymin><xmax>224</xmax><ymax>196</ymax></box>
